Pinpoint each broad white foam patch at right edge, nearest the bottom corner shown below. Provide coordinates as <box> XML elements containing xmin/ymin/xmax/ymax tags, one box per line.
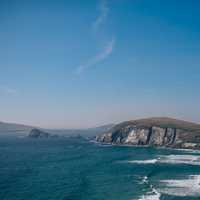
<box><xmin>159</xmin><ymin>175</ymin><xmax>200</xmax><ymax>197</ymax></box>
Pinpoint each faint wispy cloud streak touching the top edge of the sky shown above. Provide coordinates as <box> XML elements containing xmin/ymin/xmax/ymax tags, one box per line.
<box><xmin>93</xmin><ymin>0</ymin><xmax>109</xmax><ymax>31</ymax></box>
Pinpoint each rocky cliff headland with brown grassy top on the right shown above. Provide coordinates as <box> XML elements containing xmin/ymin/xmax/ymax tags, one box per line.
<box><xmin>96</xmin><ymin>117</ymin><xmax>200</xmax><ymax>149</ymax></box>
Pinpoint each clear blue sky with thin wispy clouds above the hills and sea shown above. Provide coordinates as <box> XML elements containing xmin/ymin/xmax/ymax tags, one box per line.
<box><xmin>0</xmin><ymin>0</ymin><xmax>200</xmax><ymax>128</ymax></box>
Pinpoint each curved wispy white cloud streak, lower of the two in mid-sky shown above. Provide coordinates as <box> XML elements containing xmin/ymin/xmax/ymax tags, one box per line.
<box><xmin>76</xmin><ymin>38</ymin><xmax>115</xmax><ymax>74</ymax></box>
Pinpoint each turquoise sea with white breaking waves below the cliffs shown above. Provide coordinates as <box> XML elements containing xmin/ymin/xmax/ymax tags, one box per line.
<box><xmin>0</xmin><ymin>138</ymin><xmax>200</xmax><ymax>200</ymax></box>
